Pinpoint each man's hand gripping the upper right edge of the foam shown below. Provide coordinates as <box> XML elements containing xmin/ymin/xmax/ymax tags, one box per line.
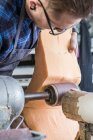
<box><xmin>68</xmin><ymin>31</ymin><xmax>79</xmax><ymax>57</ymax></box>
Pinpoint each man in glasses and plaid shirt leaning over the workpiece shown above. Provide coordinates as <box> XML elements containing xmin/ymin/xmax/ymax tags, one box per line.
<box><xmin>0</xmin><ymin>0</ymin><xmax>93</xmax><ymax>75</ymax></box>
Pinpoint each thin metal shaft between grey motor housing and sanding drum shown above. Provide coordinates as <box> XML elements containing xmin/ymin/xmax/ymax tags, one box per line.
<box><xmin>25</xmin><ymin>92</ymin><xmax>49</xmax><ymax>101</ymax></box>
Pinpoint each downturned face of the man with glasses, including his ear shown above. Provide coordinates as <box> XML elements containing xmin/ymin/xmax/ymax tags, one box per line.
<box><xmin>26</xmin><ymin>0</ymin><xmax>81</xmax><ymax>33</ymax></box>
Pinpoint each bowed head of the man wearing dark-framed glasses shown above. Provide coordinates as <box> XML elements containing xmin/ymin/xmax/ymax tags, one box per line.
<box><xmin>26</xmin><ymin>0</ymin><xmax>93</xmax><ymax>34</ymax></box>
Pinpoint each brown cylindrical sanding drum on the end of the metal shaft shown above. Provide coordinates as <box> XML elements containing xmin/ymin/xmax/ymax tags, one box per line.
<box><xmin>45</xmin><ymin>83</ymin><xmax>78</xmax><ymax>106</ymax></box>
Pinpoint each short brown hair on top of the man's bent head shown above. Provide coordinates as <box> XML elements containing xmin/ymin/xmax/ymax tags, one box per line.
<box><xmin>49</xmin><ymin>0</ymin><xmax>93</xmax><ymax>18</ymax></box>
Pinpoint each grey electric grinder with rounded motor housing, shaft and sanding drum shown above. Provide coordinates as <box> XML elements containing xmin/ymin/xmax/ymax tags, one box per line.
<box><xmin>0</xmin><ymin>76</ymin><xmax>77</xmax><ymax>129</ymax></box>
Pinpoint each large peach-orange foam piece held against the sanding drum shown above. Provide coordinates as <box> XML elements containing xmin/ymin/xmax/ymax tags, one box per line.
<box><xmin>23</xmin><ymin>30</ymin><xmax>81</xmax><ymax>140</ymax></box>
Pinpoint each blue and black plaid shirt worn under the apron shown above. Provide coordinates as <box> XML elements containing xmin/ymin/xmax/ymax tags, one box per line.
<box><xmin>0</xmin><ymin>0</ymin><xmax>40</xmax><ymax>61</ymax></box>
